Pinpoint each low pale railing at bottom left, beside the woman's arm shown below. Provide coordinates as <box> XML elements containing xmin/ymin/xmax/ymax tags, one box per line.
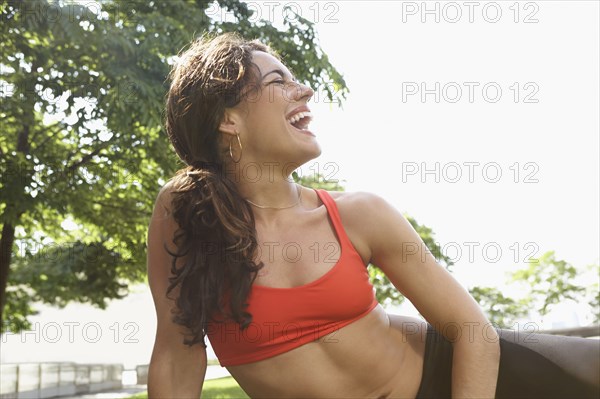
<box><xmin>0</xmin><ymin>363</ymin><xmax>123</xmax><ymax>399</ymax></box>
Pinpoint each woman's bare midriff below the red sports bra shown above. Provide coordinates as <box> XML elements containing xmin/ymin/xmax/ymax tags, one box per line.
<box><xmin>227</xmin><ymin>305</ymin><xmax>426</xmax><ymax>398</ymax></box>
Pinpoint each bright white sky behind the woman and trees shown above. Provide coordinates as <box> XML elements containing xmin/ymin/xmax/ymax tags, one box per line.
<box><xmin>0</xmin><ymin>1</ymin><xmax>600</xmax><ymax>364</ymax></box>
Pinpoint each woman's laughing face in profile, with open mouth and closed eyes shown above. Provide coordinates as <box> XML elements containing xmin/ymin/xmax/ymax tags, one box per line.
<box><xmin>220</xmin><ymin>51</ymin><xmax>321</xmax><ymax>172</ymax></box>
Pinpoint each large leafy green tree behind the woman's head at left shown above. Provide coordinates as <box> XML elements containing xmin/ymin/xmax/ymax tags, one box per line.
<box><xmin>0</xmin><ymin>0</ymin><xmax>347</xmax><ymax>330</ymax></box>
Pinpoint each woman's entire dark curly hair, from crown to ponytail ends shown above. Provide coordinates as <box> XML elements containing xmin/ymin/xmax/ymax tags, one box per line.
<box><xmin>166</xmin><ymin>33</ymin><xmax>280</xmax><ymax>347</ymax></box>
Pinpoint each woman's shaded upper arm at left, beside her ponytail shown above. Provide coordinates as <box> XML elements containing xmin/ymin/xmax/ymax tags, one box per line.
<box><xmin>147</xmin><ymin>184</ymin><xmax>207</xmax><ymax>390</ymax></box>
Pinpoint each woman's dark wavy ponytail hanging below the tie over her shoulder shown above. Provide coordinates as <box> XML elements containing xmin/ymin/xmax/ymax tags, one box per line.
<box><xmin>167</xmin><ymin>163</ymin><xmax>263</xmax><ymax>345</ymax></box>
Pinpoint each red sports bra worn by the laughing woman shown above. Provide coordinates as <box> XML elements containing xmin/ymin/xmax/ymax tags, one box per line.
<box><xmin>207</xmin><ymin>189</ymin><xmax>378</xmax><ymax>367</ymax></box>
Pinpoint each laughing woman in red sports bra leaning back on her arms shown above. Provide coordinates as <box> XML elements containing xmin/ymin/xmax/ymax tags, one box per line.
<box><xmin>148</xmin><ymin>34</ymin><xmax>599</xmax><ymax>398</ymax></box>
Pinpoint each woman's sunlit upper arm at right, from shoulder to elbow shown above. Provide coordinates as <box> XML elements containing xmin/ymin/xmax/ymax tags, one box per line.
<box><xmin>361</xmin><ymin>193</ymin><xmax>489</xmax><ymax>341</ymax></box>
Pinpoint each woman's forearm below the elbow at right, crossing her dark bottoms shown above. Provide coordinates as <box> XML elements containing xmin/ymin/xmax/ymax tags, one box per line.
<box><xmin>452</xmin><ymin>328</ymin><xmax>500</xmax><ymax>399</ymax></box>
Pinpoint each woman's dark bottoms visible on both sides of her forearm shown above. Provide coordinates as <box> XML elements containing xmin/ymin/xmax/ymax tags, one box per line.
<box><xmin>417</xmin><ymin>324</ymin><xmax>600</xmax><ymax>399</ymax></box>
